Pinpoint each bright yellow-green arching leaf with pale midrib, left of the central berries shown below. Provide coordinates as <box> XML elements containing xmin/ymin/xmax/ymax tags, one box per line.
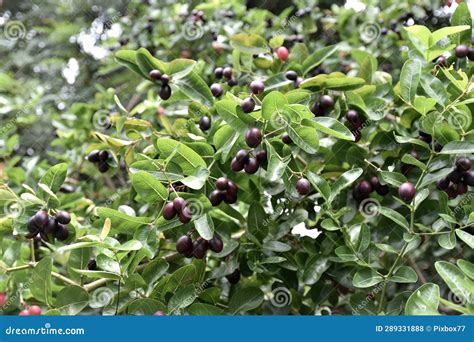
<box><xmin>156</xmin><ymin>138</ymin><xmax>207</xmax><ymax>175</ymax></box>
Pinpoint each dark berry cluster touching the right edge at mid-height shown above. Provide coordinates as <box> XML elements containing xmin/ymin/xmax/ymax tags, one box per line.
<box><xmin>437</xmin><ymin>157</ymin><xmax>474</xmax><ymax>199</ymax></box>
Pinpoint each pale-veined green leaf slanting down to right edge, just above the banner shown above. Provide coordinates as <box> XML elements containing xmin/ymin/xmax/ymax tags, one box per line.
<box><xmin>435</xmin><ymin>261</ymin><xmax>474</xmax><ymax>303</ymax></box>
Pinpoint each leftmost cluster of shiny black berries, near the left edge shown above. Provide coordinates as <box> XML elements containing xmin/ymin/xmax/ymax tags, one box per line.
<box><xmin>27</xmin><ymin>210</ymin><xmax>71</xmax><ymax>241</ymax></box>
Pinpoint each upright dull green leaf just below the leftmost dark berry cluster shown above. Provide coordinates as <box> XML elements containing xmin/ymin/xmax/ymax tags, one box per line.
<box><xmin>29</xmin><ymin>256</ymin><xmax>53</xmax><ymax>304</ymax></box>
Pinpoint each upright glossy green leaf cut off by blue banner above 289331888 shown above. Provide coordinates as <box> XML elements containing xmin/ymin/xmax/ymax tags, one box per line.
<box><xmin>405</xmin><ymin>283</ymin><xmax>440</xmax><ymax>316</ymax></box>
